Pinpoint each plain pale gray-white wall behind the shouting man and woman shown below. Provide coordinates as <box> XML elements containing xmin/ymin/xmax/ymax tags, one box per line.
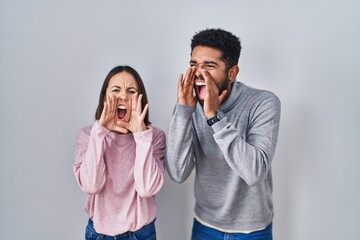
<box><xmin>0</xmin><ymin>0</ymin><xmax>360</xmax><ymax>240</ymax></box>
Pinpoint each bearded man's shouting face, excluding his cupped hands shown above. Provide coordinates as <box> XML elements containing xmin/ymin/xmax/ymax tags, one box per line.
<box><xmin>190</xmin><ymin>46</ymin><xmax>229</xmax><ymax>103</ymax></box>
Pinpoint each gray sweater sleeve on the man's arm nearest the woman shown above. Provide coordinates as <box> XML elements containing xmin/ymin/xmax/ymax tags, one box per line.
<box><xmin>166</xmin><ymin>104</ymin><xmax>195</xmax><ymax>183</ymax></box>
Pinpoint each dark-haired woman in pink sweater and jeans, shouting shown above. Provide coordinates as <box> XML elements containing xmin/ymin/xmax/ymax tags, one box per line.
<box><xmin>73</xmin><ymin>66</ymin><xmax>166</xmax><ymax>240</ymax></box>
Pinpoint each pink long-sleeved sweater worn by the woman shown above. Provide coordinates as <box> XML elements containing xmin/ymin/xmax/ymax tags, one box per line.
<box><xmin>73</xmin><ymin>122</ymin><xmax>166</xmax><ymax>236</ymax></box>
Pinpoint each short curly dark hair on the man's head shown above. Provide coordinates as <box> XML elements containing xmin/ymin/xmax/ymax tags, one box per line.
<box><xmin>191</xmin><ymin>28</ymin><xmax>241</xmax><ymax>69</ymax></box>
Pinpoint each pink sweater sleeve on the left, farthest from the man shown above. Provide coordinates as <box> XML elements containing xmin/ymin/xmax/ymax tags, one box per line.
<box><xmin>73</xmin><ymin>122</ymin><xmax>109</xmax><ymax>194</ymax></box>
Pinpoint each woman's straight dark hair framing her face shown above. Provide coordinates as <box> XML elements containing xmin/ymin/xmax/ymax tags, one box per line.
<box><xmin>95</xmin><ymin>66</ymin><xmax>151</xmax><ymax>125</ymax></box>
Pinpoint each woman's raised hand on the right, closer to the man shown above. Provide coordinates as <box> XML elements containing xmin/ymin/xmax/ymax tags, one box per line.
<box><xmin>116</xmin><ymin>93</ymin><xmax>149</xmax><ymax>133</ymax></box>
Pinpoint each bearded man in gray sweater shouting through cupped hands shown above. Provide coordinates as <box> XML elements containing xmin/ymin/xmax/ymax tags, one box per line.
<box><xmin>167</xmin><ymin>29</ymin><xmax>280</xmax><ymax>240</ymax></box>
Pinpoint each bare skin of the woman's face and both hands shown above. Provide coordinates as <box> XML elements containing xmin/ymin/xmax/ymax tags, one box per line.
<box><xmin>99</xmin><ymin>72</ymin><xmax>149</xmax><ymax>134</ymax></box>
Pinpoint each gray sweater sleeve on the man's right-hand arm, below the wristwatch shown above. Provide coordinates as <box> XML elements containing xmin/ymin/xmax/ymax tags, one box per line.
<box><xmin>212</xmin><ymin>96</ymin><xmax>280</xmax><ymax>186</ymax></box>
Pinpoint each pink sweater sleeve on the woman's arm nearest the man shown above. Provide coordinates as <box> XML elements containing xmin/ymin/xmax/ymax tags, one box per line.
<box><xmin>134</xmin><ymin>127</ymin><xmax>166</xmax><ymax>197</ymax></box>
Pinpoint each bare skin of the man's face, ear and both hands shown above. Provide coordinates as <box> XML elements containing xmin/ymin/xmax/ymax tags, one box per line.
<box><xmin>178</xmin><ymin>46</ymin><xmax>239</xmax><ymax>119</ymax></box>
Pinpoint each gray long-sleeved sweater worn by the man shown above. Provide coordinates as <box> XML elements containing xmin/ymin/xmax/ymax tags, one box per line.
<box><xmin>166</xmin><ymin>82</ymin><xmax>280</xmax><ymax>231</ymax></box>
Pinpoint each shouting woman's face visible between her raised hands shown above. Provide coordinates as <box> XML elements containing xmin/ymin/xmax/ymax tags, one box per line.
<box><xmin>106</xmin><ymin>71</ymin><xmax>138</xmax><ymax>122</ymax></box>
